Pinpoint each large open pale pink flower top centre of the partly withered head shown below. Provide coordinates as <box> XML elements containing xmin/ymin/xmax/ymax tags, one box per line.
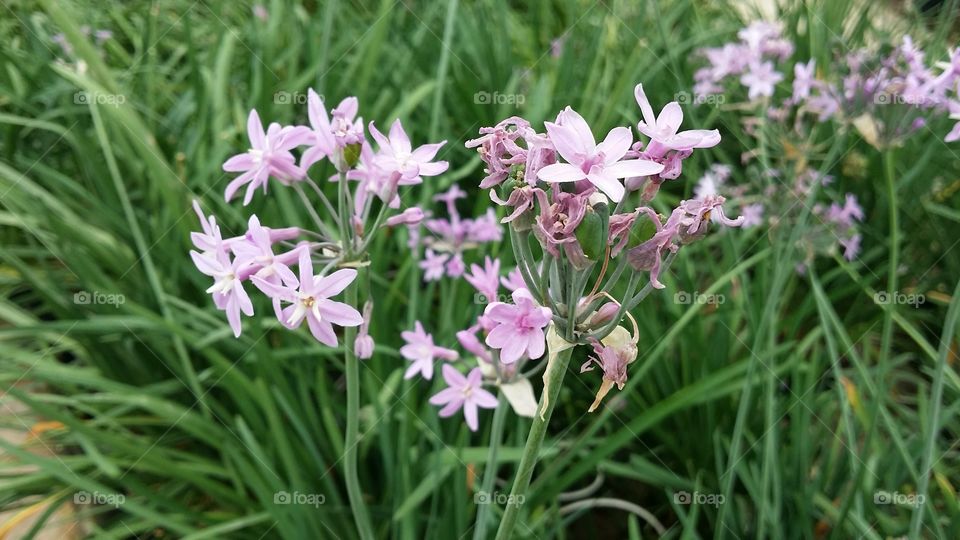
<box><xmin>537</xmin><ymin>107</ymin><xmax>663</xmax><ymax>202</ymax></box>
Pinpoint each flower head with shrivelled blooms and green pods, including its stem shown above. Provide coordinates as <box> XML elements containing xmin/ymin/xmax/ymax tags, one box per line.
<box><xmin>462</xmin><ymin>85</ymin><xmax>743</xmax><ymax>538</ymax></box>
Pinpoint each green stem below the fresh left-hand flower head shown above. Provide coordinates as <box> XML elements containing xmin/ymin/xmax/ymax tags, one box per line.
<box><xmin>343</xmin><ymin>286</ymin><xmax>373</xmax><ymax>540</ymax></box>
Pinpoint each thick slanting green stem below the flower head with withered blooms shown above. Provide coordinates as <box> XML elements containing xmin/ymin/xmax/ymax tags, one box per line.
<box><xmin>497</xmin><ymin>347</ymin><xmax>573</xmax><ymax>540</ymax></box>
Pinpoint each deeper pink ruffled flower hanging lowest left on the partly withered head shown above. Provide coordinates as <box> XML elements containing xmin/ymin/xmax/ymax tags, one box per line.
<box><xmin>483</xmin><ymin>289</ymin><xmax>551</xmax><ymax>364</ymax></box>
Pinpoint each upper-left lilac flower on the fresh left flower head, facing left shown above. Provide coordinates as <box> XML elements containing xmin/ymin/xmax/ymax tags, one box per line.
<box><xmin>223</xmin><ymin>110</ymin><xmax>307</xmax><ymax>206</ymax></box>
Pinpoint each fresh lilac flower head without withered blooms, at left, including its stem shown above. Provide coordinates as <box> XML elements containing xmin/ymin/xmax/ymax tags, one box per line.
<box><xmin>190</xmin><ymin>89</ymin><xmax>448</xmax><ymax>538</ymax></box>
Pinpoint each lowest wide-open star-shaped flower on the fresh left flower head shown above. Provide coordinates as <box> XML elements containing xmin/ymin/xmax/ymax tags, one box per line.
<box><xmin>252</xmin><ymin>250</ymin><xmax>363</xmax><ymax>347</ymax></box>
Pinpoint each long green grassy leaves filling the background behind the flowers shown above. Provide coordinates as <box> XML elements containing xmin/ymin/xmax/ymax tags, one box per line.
<box><xmin>0</xmin><ymin>0</ymin><xmax>960</xmax><ymax>539</ymax></box>
